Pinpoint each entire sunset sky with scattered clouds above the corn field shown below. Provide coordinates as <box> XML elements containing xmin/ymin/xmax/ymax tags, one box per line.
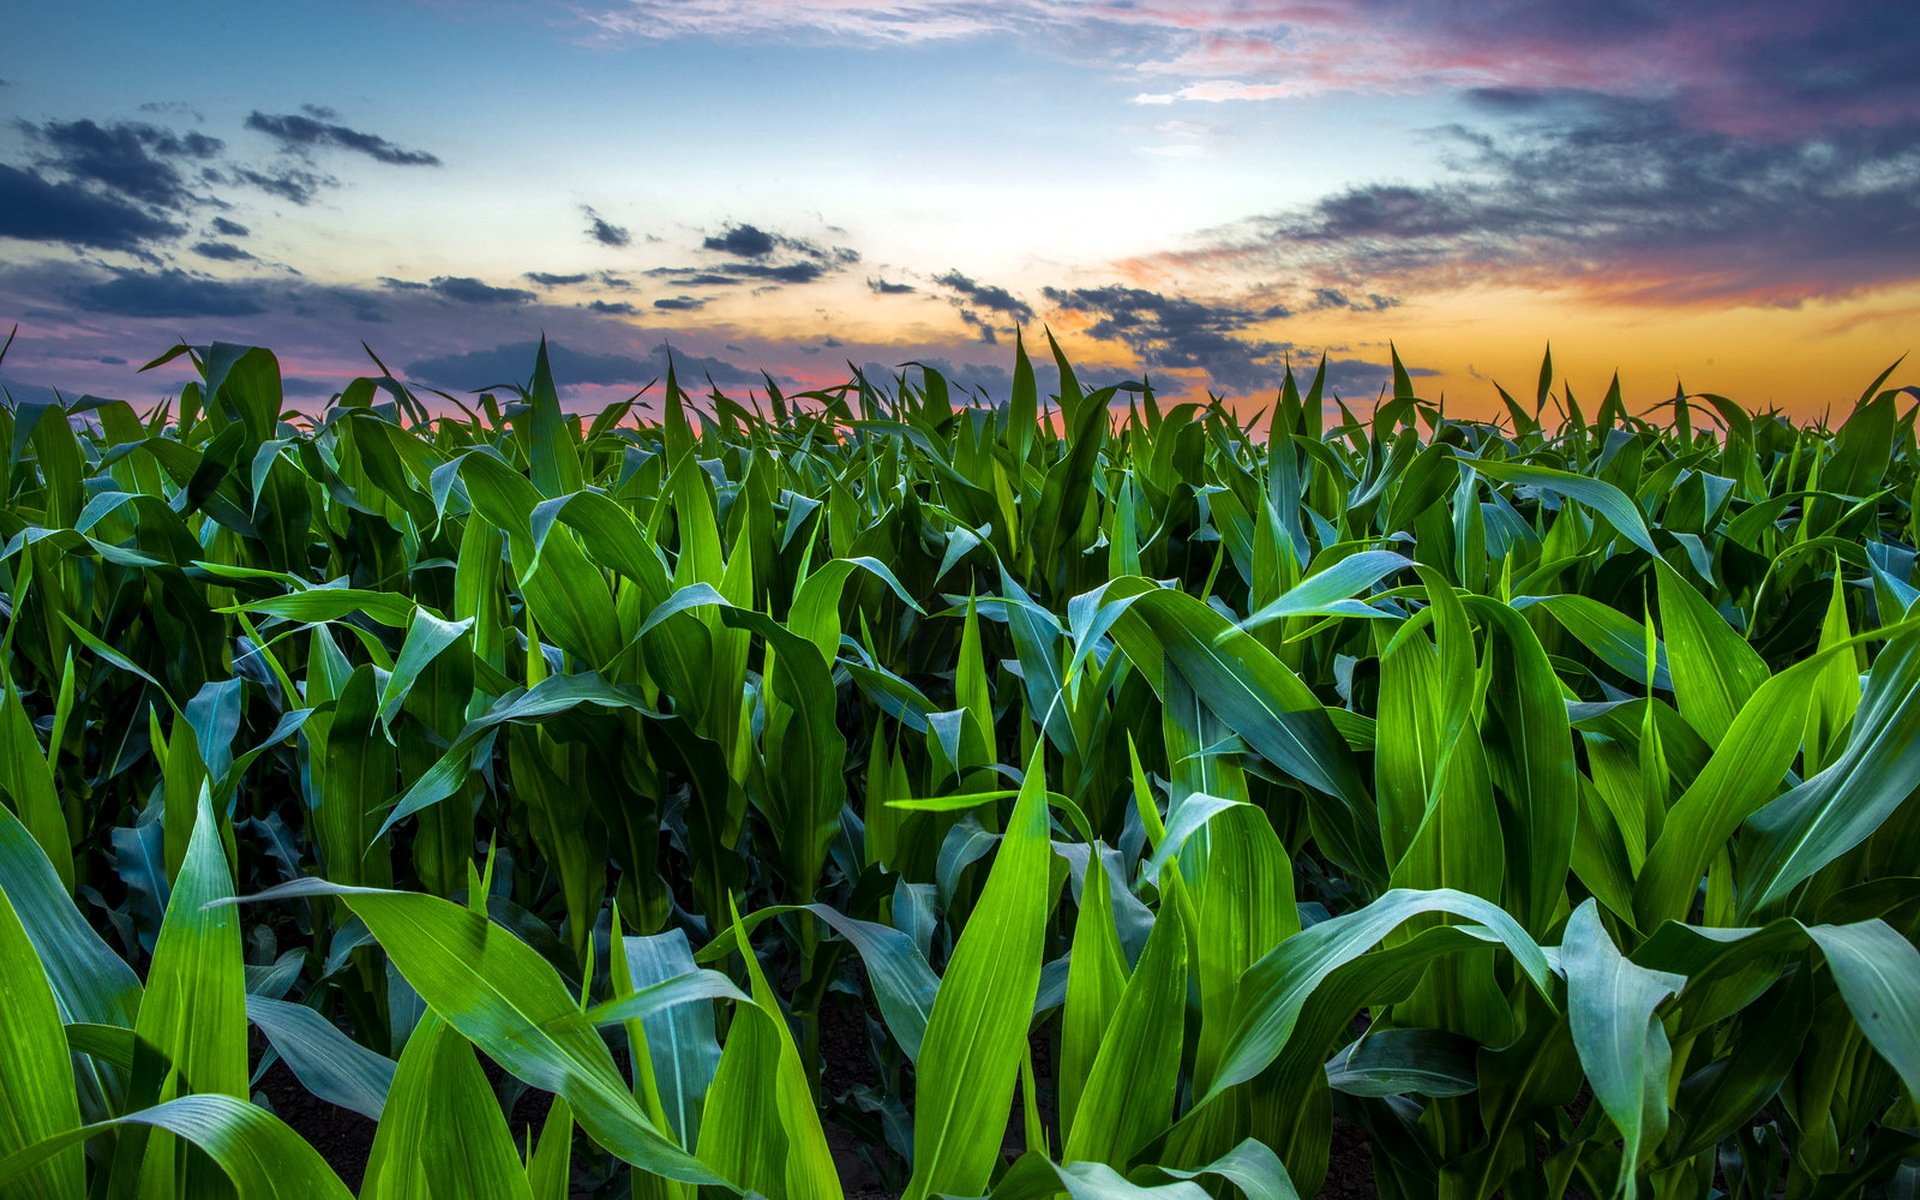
<box><xmin>0</xmin><ymin>0</ymin><xmax>1920</xmax><ymax>417</ymax></box>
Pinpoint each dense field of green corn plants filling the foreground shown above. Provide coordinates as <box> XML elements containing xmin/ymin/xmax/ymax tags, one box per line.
<box><xmin>0</xmin><ymin>330</ymin><xmax>1920</xmax><ymax>1200</ymax></box>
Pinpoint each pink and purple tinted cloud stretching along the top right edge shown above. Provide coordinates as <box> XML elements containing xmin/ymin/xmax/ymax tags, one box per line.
<box><xmin>589</xmin><ymin>0</ymin><xmax>1920</xmax><ymax>138</ymax></box>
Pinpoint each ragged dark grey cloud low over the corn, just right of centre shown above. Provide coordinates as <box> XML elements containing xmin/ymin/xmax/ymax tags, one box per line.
<box><xmin>1044</xmin><ymin>284</ymin><xmax>1292</xmax><ymax>392</ymax></box>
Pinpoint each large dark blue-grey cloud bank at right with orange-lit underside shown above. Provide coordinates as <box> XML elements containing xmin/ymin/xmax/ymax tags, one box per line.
<box><xmin>1139</xmin><ymin>92</ymin><xmax>1920</xmax><ymax>307</ymax></box>
